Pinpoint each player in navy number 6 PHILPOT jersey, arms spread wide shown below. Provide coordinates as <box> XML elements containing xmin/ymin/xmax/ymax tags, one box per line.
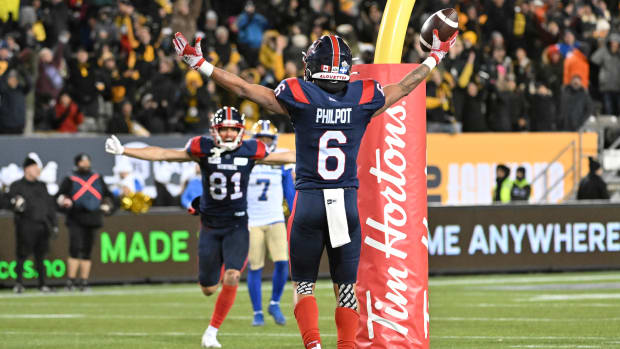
<box><xmin>173</xmin><ymin>30</ymin><xmax>458</xmax><ymax>349</ymax></box>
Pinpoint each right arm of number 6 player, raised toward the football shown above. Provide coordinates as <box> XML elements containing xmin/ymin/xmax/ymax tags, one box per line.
<box><xmin>373</xmin><ymin>29</ymin><xmax>458</xmax><ymax>117</ymax></box>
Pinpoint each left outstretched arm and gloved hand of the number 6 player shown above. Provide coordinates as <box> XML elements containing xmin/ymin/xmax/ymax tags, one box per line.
<box><xmin>172</xmin><ymin>33</ymin><xmax>288</xmax><ymax>115</ymax></box>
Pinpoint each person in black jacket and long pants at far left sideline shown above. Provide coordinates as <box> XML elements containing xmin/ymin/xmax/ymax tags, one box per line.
<box><xmin>9</xmin><ymin>154</ymin><xmax>58</xmax><ymax>293</ymax></box>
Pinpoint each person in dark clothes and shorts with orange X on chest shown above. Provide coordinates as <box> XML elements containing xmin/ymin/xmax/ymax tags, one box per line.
<box><xmin>56</xmin><ymin>153</ymin><xmax>114</xmax><ymax>291</ymax></box>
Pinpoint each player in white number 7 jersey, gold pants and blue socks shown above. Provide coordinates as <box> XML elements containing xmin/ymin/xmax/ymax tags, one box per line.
<box><xmin>248</xmin><ymin>120</ymin><xmax>295</xmax><ymax>326</ymax></box>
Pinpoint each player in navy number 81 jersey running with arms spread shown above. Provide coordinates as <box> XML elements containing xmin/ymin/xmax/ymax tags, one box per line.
<box><xmin>105</xmin><ymin>107</ymin><xmax>295</xmax><ymax>348</ymax></box>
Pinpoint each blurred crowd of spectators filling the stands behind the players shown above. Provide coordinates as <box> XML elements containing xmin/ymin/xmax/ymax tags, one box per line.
<box><xmin>0</xmin><ymin>0</ymin><xmax>620</xmax><ymax>136</ymax></box>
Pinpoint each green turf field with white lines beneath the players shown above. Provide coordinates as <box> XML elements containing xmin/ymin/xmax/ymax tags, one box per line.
<box><xmin>0</xmin><ymin>272</ymin><xmax>620</xmax><ymax>349</ymax></box>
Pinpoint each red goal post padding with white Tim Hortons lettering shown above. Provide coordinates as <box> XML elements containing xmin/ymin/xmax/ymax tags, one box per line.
<box><xmin>351</xmin><ymin>64</ymin><xmax>429</xmax><ymax>349</ymax></box>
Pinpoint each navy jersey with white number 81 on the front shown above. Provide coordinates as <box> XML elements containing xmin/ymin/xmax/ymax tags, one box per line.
<box><xmin>185</xmin><ymin>136</ymin><xmax>268</xmax><ymax>218</ymax></box>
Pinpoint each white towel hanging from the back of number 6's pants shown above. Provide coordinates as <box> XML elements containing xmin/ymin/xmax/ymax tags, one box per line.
<box><xmin>323</xmin><ymin>188</ymin><xmax>351</xmax><ymax>248</ymax></box>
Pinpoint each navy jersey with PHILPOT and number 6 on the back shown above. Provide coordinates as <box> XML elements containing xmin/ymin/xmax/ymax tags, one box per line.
<box><xmin>274</xmin><ymin>78</ymin><xmax>385</xmax><ymax>190</ymax></box>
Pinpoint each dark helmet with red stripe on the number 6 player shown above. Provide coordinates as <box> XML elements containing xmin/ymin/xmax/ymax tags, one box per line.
<box><xmin>303</xmin><ymin>35</ymin><xmax>353</xmax><ymax>82</ymax></box>
